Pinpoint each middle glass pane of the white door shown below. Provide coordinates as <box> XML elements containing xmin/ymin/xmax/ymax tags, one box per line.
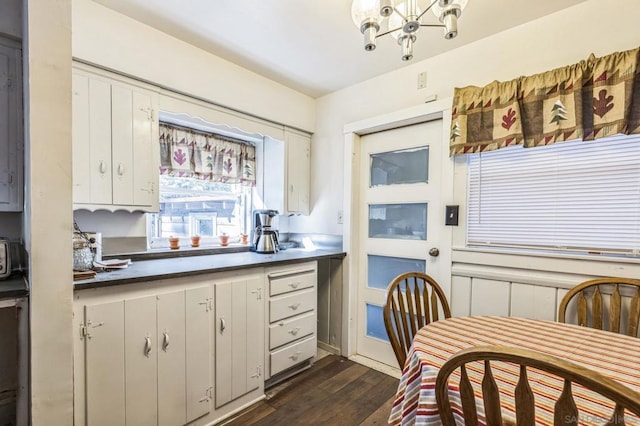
<box><xmin>369</xmin><ymin>203</ymin><xmax>427</xmax><ymax>240</ymax></box>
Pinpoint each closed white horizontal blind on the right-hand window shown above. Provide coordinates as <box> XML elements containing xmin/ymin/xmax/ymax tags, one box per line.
<box><xmin>467</xmin><ymin>135</ymin><xmax>640</xmax><ymax>255</ymax></box>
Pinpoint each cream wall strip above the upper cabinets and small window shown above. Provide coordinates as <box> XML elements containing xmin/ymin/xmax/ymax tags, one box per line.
<box><xmin>73</xmin><ymin>0</ymin><xmax>315</xmax><ymax>131</ymax></box>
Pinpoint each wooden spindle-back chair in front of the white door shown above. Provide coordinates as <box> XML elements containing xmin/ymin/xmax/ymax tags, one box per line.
<box><xmin>383</xmin><ymin>272</ymin><xmax>451</xmax><ymax>370</ymax></box>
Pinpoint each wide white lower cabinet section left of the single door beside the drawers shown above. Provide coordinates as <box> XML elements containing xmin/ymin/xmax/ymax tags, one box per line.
<box><xmin>76</xmin><ymin>285</ymin><xmax>212</xmax><ymax>426</ymax></box>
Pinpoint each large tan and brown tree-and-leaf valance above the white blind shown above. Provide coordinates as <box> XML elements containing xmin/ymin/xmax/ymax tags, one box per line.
<box><xmin>449</xmin><ymin>48</ymin><xmax>640</xmax><ymax>155</ymax></box>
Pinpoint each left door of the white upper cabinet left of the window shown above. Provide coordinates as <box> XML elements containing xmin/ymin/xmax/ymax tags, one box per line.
<box><xmin>72</xmin><ymin>73</ymin><xmax>112</xmax><ymax>204</ymax></box>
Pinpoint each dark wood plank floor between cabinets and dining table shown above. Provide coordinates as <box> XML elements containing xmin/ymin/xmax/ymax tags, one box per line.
<box><xmin>224</xmin><ymin>355</ymin><xmax>398</xmax><ymax>426</ymax></box>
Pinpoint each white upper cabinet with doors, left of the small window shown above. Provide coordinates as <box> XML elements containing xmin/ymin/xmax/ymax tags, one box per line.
<box><xmin>73</xmin><ymin>65</ymin><xmax>160</xmax><ymax>211</ymax></box>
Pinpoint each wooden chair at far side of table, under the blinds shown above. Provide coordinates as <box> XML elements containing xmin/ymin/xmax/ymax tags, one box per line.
<box><xmin>558</xmin><ymin>278</ymin><xmax>640</xmax><ymax>337</ymax></box>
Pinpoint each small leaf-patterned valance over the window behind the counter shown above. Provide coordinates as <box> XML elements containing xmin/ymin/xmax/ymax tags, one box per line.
<box><xmin>160</xmin><ymin>123</ymin><xmax>256</xmax><ymax>186</ymax></box>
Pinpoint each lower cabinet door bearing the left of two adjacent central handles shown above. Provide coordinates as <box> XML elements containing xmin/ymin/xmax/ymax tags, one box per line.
<box><xmin>124</xmin><ymin>295</ymin><xmax>158</xmax><ymax>425</ymax></box>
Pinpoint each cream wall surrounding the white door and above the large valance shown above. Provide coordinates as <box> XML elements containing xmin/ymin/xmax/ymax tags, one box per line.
<box><xmin>289</xmin><ymin>0</ymin><xmax>640</xmax><ymax>234</ymax></box>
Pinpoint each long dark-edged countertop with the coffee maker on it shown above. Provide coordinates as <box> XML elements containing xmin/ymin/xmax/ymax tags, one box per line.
<box><xmin>73</xmin><ymin>249</ymin><xmax>346</xmax><ymax>290</ymax></box>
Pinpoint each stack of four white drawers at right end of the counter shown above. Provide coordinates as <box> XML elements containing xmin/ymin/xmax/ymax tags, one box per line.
<box><xmin>265</xmin><ymin>262</ymin><xmax>318</xmax><ymax>379</ymax></box>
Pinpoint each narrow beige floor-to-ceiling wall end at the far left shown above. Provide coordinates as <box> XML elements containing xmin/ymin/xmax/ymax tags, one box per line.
<box><xmin>24</xmin><ymin>0</ymin><xmax>73</xmax><ymax>426</ymax></box>
